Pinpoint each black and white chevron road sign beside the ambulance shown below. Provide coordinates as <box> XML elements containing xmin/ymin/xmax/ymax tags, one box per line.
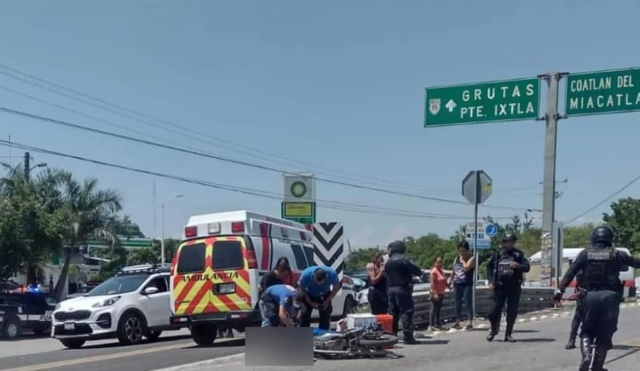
<box><xmin>313</xmin><ymin>222</ymin><xmax>344</xmax><ymax>294</ymax></box>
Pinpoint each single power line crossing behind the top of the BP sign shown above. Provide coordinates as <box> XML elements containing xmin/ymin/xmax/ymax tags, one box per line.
<box><xmin>0</xmin><ymin>107</ymin><xmax>528</xmax><ymax>211</ymax></box>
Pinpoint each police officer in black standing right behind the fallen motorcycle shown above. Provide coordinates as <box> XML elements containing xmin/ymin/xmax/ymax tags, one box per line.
<box><xmin>384</xmin><ymin>241</ymin><xmax>422</xmax><ymax>344</ymax></box>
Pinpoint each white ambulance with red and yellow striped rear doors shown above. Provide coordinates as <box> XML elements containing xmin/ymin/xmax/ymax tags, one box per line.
<box><xmin>171</xmin><ymin>211</ymin><xmax>357</xmax><ymax>345</ymax></box>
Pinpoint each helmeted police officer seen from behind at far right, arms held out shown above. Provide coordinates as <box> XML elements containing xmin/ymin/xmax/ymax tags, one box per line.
<box><xmin>554</xmin><ymin>227</ymin><xmax>640</xmax><ymax>371</ymax></box>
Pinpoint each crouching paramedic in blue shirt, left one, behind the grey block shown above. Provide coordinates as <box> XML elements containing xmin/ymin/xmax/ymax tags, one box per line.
<box><xmin>260</xmin><ymin>285</ymin><xmax>303</xmax><ymax>327</ymax></box>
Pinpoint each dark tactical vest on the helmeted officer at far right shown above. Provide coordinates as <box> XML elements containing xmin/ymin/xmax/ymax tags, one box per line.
<box><xmin>583</xmin><ymin>248</ymin><xmax>619</xmax><ymax>291</ymax></box>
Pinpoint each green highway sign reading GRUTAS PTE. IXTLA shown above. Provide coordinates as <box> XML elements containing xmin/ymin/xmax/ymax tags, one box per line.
<box><xmin>424</xmin><ymin>78</ymin><xmax>540</xmax><ymax>127</ymax></box>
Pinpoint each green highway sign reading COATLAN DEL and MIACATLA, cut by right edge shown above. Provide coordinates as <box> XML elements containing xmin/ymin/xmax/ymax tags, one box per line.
<box><xmin>565</xmin><ymin>68</ymin><xmax>640</xmax><ymax>116</ymax></box>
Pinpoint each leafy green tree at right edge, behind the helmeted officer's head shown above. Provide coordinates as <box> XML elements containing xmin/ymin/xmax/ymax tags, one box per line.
<box><xmin>602</xmin><ymin>197</ymin><xmax>640</xmax><ymax>254</ymax></box>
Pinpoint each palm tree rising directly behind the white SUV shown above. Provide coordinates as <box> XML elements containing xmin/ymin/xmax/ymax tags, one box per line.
<box><xmin>54</xmin><ymin>176</ymin><xmax>122</xmax><ymax>298</ymax></box>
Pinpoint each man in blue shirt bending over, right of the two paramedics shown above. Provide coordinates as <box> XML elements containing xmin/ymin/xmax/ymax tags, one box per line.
<box><xmin>298</xmin><ymin>265</ymin><xmax>342</xmax><ymax>330</ymax></box>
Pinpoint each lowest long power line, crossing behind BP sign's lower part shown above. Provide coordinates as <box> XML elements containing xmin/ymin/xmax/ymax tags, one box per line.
<box><xmin>0</xmin><ymin>140</ymin><xmax>509</xmax><ymax>220</ymax></box>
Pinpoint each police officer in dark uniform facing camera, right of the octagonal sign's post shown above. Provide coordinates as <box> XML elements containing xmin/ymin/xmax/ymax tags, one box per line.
<box><xmin>487</xmin><ymin>233</ymin><xmax>530</xmax><ymax>343</ymax></box>
